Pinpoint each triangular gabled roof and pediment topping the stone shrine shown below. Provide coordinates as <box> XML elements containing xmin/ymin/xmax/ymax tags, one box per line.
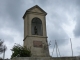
<box><xmin>23</xmin><ymin>5</ymin><xmax>47</xmax><ymax>18</ymax></box>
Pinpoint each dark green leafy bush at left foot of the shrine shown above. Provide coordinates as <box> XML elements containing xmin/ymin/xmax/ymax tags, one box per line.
<box><xmin>11</xmin><ymin>44</ymin><xmax>31</xmax><ymax>58</ymax></box>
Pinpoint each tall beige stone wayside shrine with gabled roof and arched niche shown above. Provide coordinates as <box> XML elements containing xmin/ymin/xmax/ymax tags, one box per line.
<box><xmin>23</xmin><ymin>5</ymin><xmax>49</xmax><ymax>57</ymax></box>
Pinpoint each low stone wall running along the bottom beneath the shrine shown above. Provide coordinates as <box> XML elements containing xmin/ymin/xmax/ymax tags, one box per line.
<box><xmin>12</xmin><ymin>57</ymin><xmax>80</xmax><ymax>60</ymax></box>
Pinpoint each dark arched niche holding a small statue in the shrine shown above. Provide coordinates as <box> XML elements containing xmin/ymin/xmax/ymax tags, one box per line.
<box><xmin>31</xmin><ymin>17</ymin><xmax>43</xmax><ymax>35</ymax></box>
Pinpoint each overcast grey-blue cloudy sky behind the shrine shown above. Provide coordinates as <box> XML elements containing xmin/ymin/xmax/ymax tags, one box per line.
<box><xmin>0</xmin><ymin>0</ymin><xmax>80</xmax><ymax>58</ymax></box>
